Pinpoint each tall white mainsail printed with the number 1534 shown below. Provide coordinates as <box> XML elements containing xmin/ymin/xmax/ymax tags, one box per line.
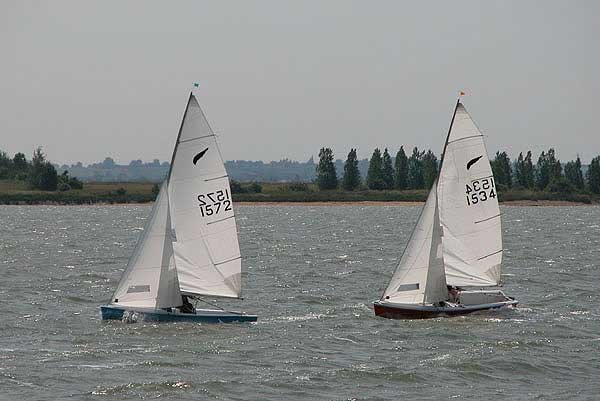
<box><xmin>438</xmin><ymin>103</ymin><xmax>502</xmax><ymax>286</ymax></box>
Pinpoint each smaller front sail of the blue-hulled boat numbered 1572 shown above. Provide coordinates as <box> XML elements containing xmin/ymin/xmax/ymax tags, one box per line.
<box><xmin>112</xmin><ymin>184</ymin><xmax>181</xmax><ymax>308</ymax></box>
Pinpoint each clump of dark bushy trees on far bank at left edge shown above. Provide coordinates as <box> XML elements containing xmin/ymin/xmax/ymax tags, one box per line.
<box><xmin>0</xmin><ymin>147</ymin><xmax>83</xmax><ymax>191</ymax></box>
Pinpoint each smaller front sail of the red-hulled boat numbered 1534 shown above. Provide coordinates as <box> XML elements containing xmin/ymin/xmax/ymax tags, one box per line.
<box><xmin>382</xmin><ymin>184</ymin><xmax>448</xmax><ymax>303</ymax></box>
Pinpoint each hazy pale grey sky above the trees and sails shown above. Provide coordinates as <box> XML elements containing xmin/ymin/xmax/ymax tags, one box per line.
<box><xmin>0</xmin><ymin>0</ymin><xmax>600</xmax><ymax>164</ymax></box>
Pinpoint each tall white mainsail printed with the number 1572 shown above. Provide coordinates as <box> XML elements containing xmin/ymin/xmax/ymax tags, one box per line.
<box><xmin>169</xmin><ymin>94</ymin><xmax>241</xmax><ymax>298</ymax></box>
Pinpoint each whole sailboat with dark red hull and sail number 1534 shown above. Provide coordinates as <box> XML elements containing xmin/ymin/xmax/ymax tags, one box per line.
<box><xmin>373</xmin><ymin>97</ymin><xmax>518</xmax><ymax>319</ymax></box>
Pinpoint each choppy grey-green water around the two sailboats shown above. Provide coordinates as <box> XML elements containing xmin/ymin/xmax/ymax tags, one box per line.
<box><xmin>0</xmin><ymin>206</ymin><xmax>600</xmax><ymax>400</ymax></box>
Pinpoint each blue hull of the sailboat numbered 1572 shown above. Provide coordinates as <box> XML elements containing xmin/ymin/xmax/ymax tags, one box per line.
<box><xmin>100</xmin><ymin>305</ymin><xmax>258</xmax><ymax>323</ymax></box>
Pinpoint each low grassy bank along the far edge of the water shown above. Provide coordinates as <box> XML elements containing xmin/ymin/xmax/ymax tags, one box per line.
<box><xmin>0</xmin><ymin>180</ymin><xmax>600</xmax><ymax>205</ymax></box>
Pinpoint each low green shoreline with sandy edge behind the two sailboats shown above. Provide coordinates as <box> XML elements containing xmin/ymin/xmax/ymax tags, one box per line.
<box><xmin>0</xmin><ymin>180</ymin><xmax>600</xmax><ymax>206</ymax></box>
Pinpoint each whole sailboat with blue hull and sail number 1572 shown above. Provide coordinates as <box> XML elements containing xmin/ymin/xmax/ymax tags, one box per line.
<box><xmin>100</xmin><ymin>91</ymin><xmax>257</xmax><ymax>323</ymax></box>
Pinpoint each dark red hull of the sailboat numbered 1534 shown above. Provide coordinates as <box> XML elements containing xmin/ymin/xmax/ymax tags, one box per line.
<box><xmin>373</xmin><ymin>299</ymin><xmax>518</xmax><ymax>319</ymax></box>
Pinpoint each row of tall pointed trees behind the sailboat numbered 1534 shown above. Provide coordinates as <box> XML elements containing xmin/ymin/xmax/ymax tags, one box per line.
<box><xmin>316</xmin><ymin>146</ymin><xmax>600</xmax><ymax>194</ymax></box>
